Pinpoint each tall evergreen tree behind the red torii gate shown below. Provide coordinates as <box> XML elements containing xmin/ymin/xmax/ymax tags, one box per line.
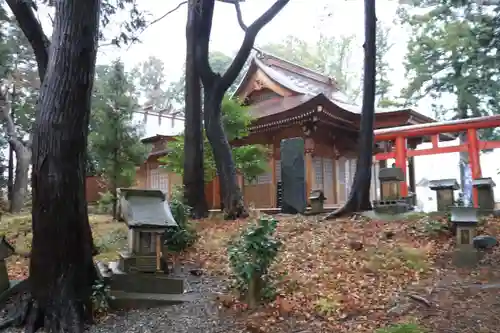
<box><xmin>400</xmin><ymin>0</ymin><xmax>500</xmax><ymax>204</ymax></box>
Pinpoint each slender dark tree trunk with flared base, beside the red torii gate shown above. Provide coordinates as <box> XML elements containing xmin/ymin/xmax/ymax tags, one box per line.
<box><xmin>326</xmin><ymin>0</ymin><xmax>377</xmax><ymax>219</ymax></box>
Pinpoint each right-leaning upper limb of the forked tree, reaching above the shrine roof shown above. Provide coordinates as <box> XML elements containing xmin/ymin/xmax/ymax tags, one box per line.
<box><xmin>219</xmin><ymin>0</ymin><xmax>290</xmax><ymax>91</ymax></box>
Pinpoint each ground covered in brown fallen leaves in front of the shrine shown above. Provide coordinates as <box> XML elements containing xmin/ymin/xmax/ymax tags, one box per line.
<box><xmin>0</xmin><ymin>214</ymin><xmax>500</xmax><ymax>333</ymax></box>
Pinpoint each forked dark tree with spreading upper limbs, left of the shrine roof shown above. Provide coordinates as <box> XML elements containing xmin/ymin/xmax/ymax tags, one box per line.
<box><xmin>195</xmin><ymin>0</ymin><xmax>290</xmax><ymax>219</ymax></box>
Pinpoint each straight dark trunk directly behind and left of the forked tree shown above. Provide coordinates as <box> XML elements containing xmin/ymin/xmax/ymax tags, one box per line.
<box><xmin>183</xmin><ymin>0</ymin><xmax>208</xmax><ymax>219</ymax></box>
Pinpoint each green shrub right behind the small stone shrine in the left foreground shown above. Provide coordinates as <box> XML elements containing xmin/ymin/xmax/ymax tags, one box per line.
<box><xmin>165</xmin><ymin>188</ymin><xmax>198</xmax><ymax>252</ymax></box>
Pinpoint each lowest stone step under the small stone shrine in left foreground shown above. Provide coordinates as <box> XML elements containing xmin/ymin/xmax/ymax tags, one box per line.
<box><xmin>110</xmin><ymin>290</ymin><xmax>197</xmax><ymax>310</ymax></box>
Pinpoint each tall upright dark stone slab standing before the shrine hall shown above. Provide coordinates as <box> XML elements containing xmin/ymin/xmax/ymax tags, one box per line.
<box><xmin>280</xmin><ymin>138</ymin><xmax>307</xmax><ymax>214</ymax></box>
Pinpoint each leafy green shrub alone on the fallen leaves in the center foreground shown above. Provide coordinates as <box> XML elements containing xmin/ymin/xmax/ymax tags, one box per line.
<box><xmin>228</xmin><ymin>217</ymin><xmax>281</xmax><ymax>307</ymax></box>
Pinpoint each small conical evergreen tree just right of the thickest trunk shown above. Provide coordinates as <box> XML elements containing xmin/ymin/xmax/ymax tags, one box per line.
<box><xmin>89</xmin><ymin>60</ymin><xmax>147</xmax><ymax>217</ymax></box>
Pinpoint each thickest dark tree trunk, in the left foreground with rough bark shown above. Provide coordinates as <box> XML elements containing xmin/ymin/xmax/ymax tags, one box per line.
<box><xmin>0</xmin><ymin>0</ymin><xmax>100</xmax><ymax>333</ymax></box>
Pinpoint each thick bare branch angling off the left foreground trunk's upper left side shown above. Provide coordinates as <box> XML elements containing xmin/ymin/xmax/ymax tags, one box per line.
<box><xmin>7</xmin><ymin>0</ymin><xmax>50</xmax><ymax>81</ymax></box>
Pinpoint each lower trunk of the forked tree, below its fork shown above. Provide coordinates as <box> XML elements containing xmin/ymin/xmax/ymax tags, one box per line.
<box><xmin>204</xmin><ymin>94</ymin><xmax>244</xmax><ymax>219</ymax></box>
